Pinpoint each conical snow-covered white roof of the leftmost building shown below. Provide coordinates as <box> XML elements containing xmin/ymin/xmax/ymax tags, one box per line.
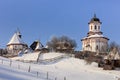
<box><xmin>7</xmin><ymin>32</ymin><xmax>25</xmax><ymax>45</ymax></box>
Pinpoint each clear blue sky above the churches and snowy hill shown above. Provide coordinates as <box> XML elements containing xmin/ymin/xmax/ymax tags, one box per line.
<box><xmin>0</xmin><ymin>0</ymin><xmax>120</xmax><ymax>50</ymax></box>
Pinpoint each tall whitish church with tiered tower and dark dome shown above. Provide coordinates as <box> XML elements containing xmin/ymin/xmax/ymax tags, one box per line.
<box><xmin>81</xmin><ymin>14</ymin><xmax>109</xmax><ymax>52</ymax></box>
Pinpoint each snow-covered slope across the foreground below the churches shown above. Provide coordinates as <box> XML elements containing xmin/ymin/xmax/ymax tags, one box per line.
<box><xmin>0</xmin><ymin>53</ymin><xmax>120</xmax><ymax>80</ymax></box>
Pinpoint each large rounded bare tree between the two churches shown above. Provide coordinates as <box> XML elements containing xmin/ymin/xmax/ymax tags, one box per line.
<box><xmin>47</xmin><ymin>36</ymin><xmax>77</xmax><ymax>51</ymax></box>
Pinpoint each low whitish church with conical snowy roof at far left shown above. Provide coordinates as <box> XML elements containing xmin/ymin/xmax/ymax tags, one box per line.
<box><xmin>7</xmin><ymin>31</ymin><xmax>28</xmax><ymax>55</ymax></box>
